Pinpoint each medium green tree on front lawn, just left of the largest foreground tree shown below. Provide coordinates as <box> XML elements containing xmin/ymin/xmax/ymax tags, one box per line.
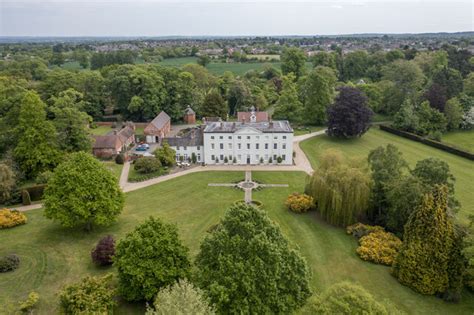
<box><xmin>114</xmin><ymin>217</ymin><xmax>191</xmax><ymax>301</ymax></box>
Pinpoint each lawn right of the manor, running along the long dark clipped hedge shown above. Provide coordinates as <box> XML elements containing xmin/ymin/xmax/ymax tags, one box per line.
<box><xmin>300</xmin><ymin>127</ymin><xmax>474</xmax><ymax>223</ymax></box>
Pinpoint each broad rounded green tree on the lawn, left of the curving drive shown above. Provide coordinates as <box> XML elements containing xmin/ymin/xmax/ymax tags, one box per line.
<box><xmin>44</xmin><ymin>152</ymin><xmax>124</xmax><ymax>230</ymax></box>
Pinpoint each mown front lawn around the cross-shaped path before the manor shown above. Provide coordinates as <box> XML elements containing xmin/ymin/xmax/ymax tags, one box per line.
<box><xmin>0</xmin><ymin>172</ymin><xmax>474</xmax><ymax>314</ymax></box>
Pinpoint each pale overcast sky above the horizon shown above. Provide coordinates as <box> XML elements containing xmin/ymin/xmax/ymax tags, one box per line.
<box><xmin>0</xmin><ymin>0</ymin><xmax>474</xmax><ymax>36</ymax></box>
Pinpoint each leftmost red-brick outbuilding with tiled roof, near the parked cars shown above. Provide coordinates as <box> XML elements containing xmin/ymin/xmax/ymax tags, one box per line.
<box><xmin>92</xmin><ymin>123</ymin><xmax>135</xmax><ymax>158</ymax></box>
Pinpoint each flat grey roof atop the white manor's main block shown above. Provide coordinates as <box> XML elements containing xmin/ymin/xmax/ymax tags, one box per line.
<box><xmin>204</xmin><ymin>120</ymin><xmax>293</xmax><ymax>133</ymax></box>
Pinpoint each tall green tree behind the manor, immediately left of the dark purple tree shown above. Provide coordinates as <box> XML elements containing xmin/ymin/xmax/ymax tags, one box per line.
<box><xmin>300</xmin><ymin>66</ymin><xmax>337</xmax><ymax>125</ymax></box>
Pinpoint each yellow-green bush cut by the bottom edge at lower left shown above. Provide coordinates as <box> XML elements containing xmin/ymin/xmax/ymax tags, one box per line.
<box><xmin>59</xmin><ymin>274</ymin><xmax>115</xmax><ymax>314</ymax></box>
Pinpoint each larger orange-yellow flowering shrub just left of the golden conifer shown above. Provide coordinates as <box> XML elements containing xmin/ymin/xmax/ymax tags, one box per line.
<box><xmin>357</xmin><ymin>231</ymin><xmax>402</xmax><ymax>266</ymax></box>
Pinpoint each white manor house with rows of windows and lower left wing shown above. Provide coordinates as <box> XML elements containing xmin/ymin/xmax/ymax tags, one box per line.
<box><xmin>164</xmin><ymin>107</ymin><xmax>293</xmax><ymax>165</ymax></box>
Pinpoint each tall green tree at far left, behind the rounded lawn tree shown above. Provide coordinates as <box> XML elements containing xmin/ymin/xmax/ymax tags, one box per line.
<box><xmin>13</xmin><ymin>92</ymin><xmax>59</xmax><ymax>178</ymax></box>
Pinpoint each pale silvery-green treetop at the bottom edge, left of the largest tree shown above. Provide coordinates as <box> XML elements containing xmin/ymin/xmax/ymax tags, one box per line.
<box><xmin>146</xmin><ymin>280</ymin><xmax>215</xmax><ymax>315</ymax></box>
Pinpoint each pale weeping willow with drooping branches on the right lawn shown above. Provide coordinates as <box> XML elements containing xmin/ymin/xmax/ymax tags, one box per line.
<box><xmin>306</xmin><ymin>151</ymin><xmax>371</xmax><ymax>227</ymax></box>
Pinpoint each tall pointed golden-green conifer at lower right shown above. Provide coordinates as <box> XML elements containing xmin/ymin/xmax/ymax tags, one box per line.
<box><xmin>392</xmin><ymin>185</ymin><xmax>454</xmax><ymax>294</ymax></box>
